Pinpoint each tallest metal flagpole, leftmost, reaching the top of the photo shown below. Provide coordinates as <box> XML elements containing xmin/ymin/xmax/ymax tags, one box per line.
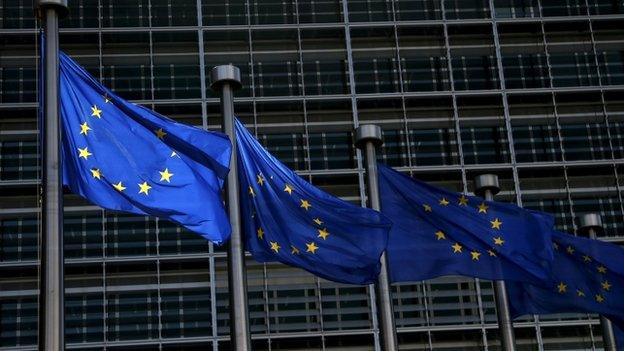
<box><xmin>35</xmin><ymin>0</ymin><xmax>68</xmax><ymax>351</ymax></box>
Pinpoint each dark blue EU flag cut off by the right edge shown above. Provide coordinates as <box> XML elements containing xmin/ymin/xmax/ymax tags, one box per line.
<box><xmin>507</xmin><ymin>232</ymin><xmax>624</xmax><ymax>327</ymax></box>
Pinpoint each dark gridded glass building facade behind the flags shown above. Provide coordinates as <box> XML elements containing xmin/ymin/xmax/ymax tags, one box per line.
<box><xmin>0</xmin><ymin>0</ymin><xmax>624</xmax><ymax>350</ymax></box>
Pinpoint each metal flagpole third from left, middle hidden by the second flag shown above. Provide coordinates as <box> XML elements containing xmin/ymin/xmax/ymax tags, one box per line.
<box><xmin>355</xmin><ymin>124</ymin><xmax>398</xmax><ymax>351</ymax></box>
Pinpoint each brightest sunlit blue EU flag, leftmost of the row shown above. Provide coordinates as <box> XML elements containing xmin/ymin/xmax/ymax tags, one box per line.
<box><xmin>60</xmin><ymin>53</ymin><xmax>232</xmax><ymax>244</ymax></box>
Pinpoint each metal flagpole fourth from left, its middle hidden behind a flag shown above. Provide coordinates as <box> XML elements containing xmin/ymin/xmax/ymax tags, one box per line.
<box><xmin>474</xmin><ymin>174</ymin><xmax>516</xmax><ymax>351</ymax></box>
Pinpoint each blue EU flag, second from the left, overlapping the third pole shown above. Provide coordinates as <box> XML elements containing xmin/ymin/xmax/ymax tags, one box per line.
<box><xmin>236</xmin><ymin>121</ymin><xmax>390</xmax><ymax>284</ymax></box>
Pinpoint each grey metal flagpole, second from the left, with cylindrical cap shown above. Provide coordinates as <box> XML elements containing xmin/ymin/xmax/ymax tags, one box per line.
<box><xmin>210</xmin><ymin>65</ymin><xmax>251</xmax><ymax>351</ymax></box>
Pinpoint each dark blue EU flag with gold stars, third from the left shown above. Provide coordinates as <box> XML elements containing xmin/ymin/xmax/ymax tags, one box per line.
<box><xmin>379</xmin><ymin>164</ymin><xmax>553</xmax><ymax>284</ymax></box>
